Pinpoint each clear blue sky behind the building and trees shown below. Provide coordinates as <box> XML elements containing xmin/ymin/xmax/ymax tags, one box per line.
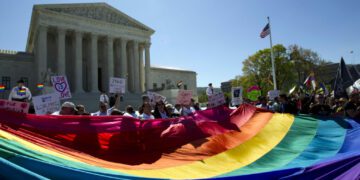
<box><xmin>0</xmin><ymin>0</ymin><xmax>360</xmax><ymax>87</ymax></box>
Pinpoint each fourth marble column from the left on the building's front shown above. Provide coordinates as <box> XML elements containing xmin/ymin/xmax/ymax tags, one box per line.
<box><xmin>89</xmin><ymin>34</ymin><xmax>99</xmax><ymax>93</ymax></box>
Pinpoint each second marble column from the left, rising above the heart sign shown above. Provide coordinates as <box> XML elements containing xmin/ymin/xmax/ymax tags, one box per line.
<box><xmin>57</xmin><ymin>28</ymin><xmax>66</xmax><ymax>75</ymax></box>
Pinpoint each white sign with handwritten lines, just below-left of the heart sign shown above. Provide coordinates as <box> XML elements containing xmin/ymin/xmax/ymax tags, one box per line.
<box><xmin>33</xmin><ymin>93</ymin><xmax>60</xmax><ymax>114</ymax></box>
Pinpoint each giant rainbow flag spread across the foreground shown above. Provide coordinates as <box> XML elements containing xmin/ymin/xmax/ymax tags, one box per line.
<box><xmin>0</xmin><ymin>105</ymin><xmax>360</xmax><ymax>179</ymax></box>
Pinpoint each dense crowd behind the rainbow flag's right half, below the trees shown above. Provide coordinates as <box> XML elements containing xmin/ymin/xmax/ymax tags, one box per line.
<box><xmin>255</xmin><ymin>91</ymin><xmax>360</xmax><ymax>119</ymax></box>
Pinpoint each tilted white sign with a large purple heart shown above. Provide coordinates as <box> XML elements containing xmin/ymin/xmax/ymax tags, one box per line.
<box><xmin>51</xmin><ymin>76</ymin><xmax>71</xmax><ymax>100</ymax></box>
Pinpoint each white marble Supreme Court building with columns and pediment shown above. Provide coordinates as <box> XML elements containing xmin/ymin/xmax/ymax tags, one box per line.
<box><xmin>0</xmin><ymin>3</ymin><xmax>196</xmax><ymax>109</ymax></box>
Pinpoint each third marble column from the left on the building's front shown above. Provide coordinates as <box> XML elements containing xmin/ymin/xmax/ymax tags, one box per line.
<box><xmin>74</xmin><ymin>31</ymin><xmax>84</xmax><ymax>93</ymax></box>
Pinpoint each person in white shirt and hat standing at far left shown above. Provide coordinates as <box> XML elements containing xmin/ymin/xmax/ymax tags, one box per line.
<box><xmin>9</xmin><ymin>79</ymin><xmax>32</xmax><ymax>102</ymax></box>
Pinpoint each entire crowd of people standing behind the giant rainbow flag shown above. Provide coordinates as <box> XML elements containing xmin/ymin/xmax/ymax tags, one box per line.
<box><xmin>5</xmin><ymin>80</ymin><xmax>360</xmax><ymax>120</ymax></box>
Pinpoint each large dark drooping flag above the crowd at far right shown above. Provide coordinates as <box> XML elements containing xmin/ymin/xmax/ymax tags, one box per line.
<box><xmin>333</xmin><ymin>58</ymin><xmax>354</xmax><ymax>98</ymax></box>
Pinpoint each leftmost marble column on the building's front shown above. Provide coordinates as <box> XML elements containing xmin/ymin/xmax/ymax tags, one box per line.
<box><xmin>36</xmin><ymin>25</ymin><xmax>47</xmax><ymax>82</ymax></box>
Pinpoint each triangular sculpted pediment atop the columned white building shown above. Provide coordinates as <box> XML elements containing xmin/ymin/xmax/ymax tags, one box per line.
<box><xmin>38</xmin><ymin>3</ymin><xmax>154</xmax><ymax>32</ymax></box>
